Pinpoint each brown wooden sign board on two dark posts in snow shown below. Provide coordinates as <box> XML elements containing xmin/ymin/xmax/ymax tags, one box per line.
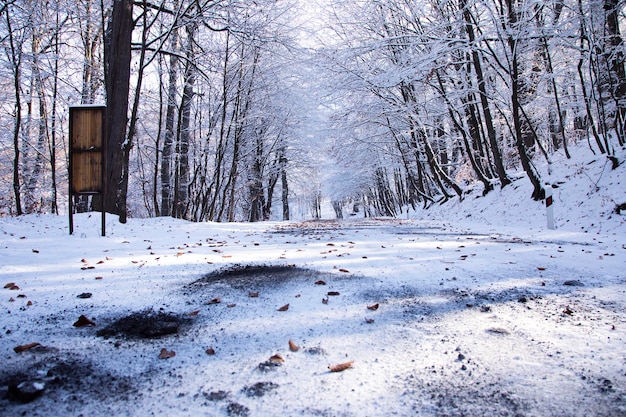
<box><xmin>69</xmin><ymin>105</ymin><xmax>106</xmax><ymax>236</ymax></box>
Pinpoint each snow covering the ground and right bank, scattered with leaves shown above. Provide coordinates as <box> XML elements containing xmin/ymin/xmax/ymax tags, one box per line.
<box><xmin>0</xmin><ymin>144</ymin><xmax>626</xmax><ymax>416</ymax></box>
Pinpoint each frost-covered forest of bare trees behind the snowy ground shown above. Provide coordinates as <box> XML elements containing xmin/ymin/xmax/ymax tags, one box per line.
<box><xmin>0</xmin><ymin>0</ymin><xmax>626</xmax><ymax>223</ymax></box>
